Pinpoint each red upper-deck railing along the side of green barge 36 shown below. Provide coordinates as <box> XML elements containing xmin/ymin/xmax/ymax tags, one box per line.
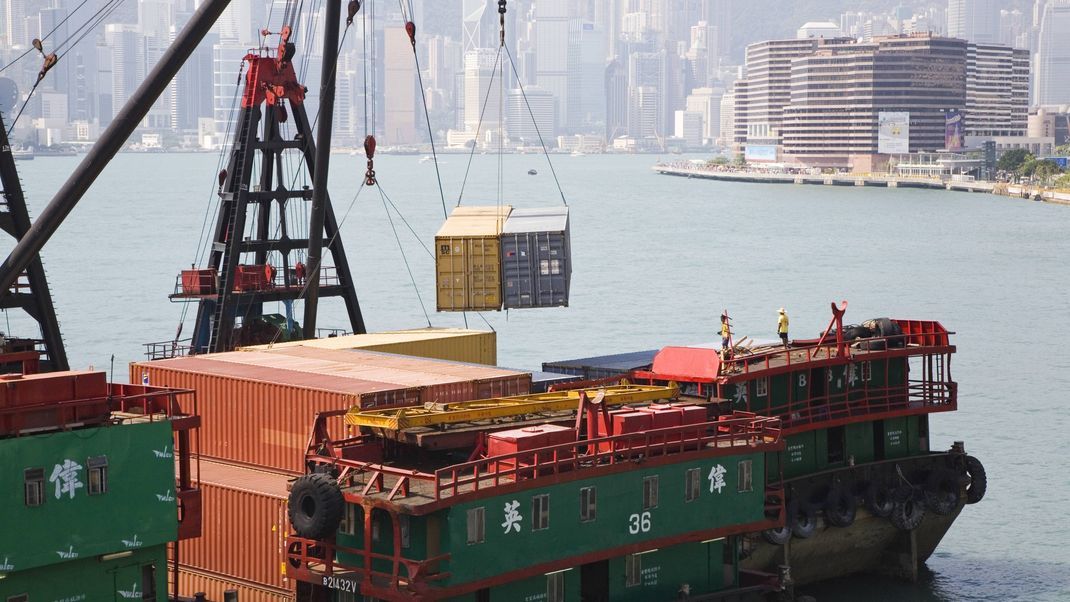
<box><xmin>434</xmin><ymin>413</ymin><xmax>782</xmax><ymax>499</ymax></box>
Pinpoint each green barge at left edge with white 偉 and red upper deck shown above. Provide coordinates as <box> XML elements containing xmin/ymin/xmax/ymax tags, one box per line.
<box><xmin>0</xmin><ymin>354</ymin><xmax>200</xmax><ymax>602</ymax></box>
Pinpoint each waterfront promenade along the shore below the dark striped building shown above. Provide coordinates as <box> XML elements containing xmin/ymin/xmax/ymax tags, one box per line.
<box><xmin>652</xmin><ymin>163</ymin><xmax>1070</xmax><ymax>205</ymax></box>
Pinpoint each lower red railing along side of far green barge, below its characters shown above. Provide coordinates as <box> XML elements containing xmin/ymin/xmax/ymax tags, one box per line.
<box><xmin>774</xmin><ymin>380</ymin><xmax>958</xmax><ymax>430</ymax></box>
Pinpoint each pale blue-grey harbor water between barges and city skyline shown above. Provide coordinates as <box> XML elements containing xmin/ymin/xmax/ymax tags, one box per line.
<box><xmin>10</xmin><ymin>154</ymin><xmax>1070</xmax><ymax>601</ymax></box>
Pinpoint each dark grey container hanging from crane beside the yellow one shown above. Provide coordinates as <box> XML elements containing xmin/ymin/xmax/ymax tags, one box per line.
<box><xmin>502</xmin><ymin>206</ymin><xmax>572</xmax><ymax>309</ymax></box>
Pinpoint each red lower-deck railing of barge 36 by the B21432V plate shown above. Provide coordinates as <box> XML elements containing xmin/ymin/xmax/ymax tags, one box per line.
<box><xmin>286</xmin><ymin>534</ymin><xmax>450</xmax><ymax>596</ymax></box>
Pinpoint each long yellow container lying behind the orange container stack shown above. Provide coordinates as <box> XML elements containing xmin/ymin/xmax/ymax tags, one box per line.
<box><xmin>242</xmin><ymin>328</ymin><xmax>498</xmax><ymax>366</ymax></box>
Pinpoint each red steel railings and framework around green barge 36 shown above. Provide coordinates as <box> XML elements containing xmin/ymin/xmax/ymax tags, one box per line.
<box><xmin>287</xmin><ymin>412</ymin><xmax>784</xmax><ymax>600</ymax></box>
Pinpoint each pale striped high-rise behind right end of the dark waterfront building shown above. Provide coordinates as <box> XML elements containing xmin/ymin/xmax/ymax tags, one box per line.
<box><xmin>964</xmin><ymin>44</ymin><xmax>1029</xmax><ymax>138</ymax></box>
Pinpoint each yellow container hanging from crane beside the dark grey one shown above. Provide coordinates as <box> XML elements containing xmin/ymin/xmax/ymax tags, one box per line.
<box><xmin>434</xmin><ymin>205</ymin><xmax>513</xmax><ymax>311</ymax></box>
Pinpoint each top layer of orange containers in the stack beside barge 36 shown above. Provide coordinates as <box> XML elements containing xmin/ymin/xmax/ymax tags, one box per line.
<box><xmin>131</xmin><ymin>348</ymin><xmax>531</xmax><ymax>474</ymax></box>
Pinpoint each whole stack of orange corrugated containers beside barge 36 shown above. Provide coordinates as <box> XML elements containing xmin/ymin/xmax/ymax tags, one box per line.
<box><xmin>131</xmin><ymin>331</ymin><xmax>532</xmax><ymax>600</ymax></box>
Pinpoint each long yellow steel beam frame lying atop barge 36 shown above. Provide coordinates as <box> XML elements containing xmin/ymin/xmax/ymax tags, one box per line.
<box><xmin>346</xmin><ymin>385</ymin><xmax>678</xmax><ymax>431</ymax></box>
